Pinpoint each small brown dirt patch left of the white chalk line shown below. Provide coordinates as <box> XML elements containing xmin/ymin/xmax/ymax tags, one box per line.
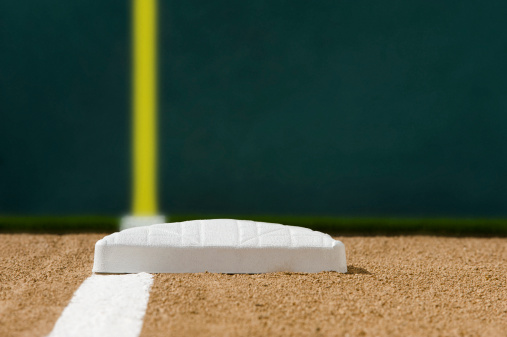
<box><xmin>0</xmin><ymin>234</ymin><xmax>105</xmax><ymax>337</ymax></box>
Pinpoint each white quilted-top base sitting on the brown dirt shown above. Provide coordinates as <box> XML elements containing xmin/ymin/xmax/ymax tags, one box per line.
<box><xmin>93</xmin><ymin>219</ymin><xmax>347</xmax><ymax>273</ymax></box>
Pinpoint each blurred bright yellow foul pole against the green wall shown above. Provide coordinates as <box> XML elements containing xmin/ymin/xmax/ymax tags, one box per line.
<box><xmin>132</xmin><ymin>0</ymin><xmax>157</xmax><ymax>216</ymax></box>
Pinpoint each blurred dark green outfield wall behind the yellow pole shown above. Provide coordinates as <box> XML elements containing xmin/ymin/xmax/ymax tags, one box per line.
<box><xmin>0</xmin><ymin>0</ymin><xmax>507</xmax><ymax>216</ymax></box>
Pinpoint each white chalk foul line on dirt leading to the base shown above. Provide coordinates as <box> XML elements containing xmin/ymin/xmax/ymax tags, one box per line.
<box><xmin>48</xmin><ymin>273</ymin><xmax>153</xmax><ymax>337</ymax></box>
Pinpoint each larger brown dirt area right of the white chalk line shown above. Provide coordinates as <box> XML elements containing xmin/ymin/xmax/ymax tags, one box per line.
<box><xmin>141</xmin><ymin>237</ymin><xmax>507</xmax><ymax>337</ymax></box>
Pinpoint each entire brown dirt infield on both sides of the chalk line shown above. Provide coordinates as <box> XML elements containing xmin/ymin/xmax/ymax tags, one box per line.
<box><xmin>0</xmin><ymin>234</ymin><xmax>507</xmax><ymax>337</ymax></box>
